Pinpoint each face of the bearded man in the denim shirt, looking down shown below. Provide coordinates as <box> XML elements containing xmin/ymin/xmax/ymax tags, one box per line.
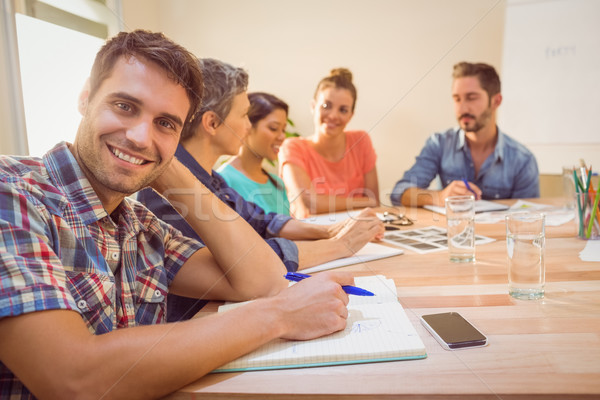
<box><xmin>452</xmin><ymin>76</ymin><xmax>500</xmax><ymax>132</ymax></box>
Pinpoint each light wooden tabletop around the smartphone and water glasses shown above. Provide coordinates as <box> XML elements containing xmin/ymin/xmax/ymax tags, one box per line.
<box><xmin>169</xmin><ymin>199</ymin><xmax>600</xmax><ymax>399</ymax></box>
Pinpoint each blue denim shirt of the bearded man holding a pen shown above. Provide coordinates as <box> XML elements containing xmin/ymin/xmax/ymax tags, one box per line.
<box><xmin>390</xmin><ymin>128</ymin><xmax>540</xmax><ymax>205</ymax></box>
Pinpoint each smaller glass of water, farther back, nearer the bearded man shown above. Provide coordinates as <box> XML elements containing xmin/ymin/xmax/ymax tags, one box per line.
<box><xmin>446</xmin><ymin>196</ymin><xmax>475</xmax><ymax>263</ymax></box>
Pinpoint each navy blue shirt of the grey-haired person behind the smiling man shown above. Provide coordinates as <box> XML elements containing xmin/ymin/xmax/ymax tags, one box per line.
<box><xmin>137</xmin><ymin>145</ymin><xmax>298</xmax><ymax>321</ymax></box>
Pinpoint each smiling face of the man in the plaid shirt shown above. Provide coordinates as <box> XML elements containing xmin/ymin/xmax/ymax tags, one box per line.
<box><xmin>73</xmin><ymin>57</ymin><xmax>190</xmax><ymax>199</ymax></box>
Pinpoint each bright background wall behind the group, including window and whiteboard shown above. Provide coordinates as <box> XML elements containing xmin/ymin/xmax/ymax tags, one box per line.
<box><xmin>0</xmin><ymin>0</ymin><xmax>600</xmax><ymax>205</ymax></box>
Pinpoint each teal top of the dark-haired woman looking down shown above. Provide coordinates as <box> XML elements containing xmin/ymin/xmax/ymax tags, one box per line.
<box><xmin>217</xmin><ymin>164</ymin><xmax>290</xmax><ymax>215</ymax></box>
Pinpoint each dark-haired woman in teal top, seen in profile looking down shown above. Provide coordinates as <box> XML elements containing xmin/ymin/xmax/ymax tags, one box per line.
<box><xmin>217</xmin><ymin>92</ymin><xmax>290</xmax><ymax>215</ymax></box>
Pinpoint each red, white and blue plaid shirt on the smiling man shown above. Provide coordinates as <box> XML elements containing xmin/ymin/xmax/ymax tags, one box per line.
<box><xmin>0</xmin><ymin>143</ymin><xmax>202</xmax><ymax>398</ymax></box>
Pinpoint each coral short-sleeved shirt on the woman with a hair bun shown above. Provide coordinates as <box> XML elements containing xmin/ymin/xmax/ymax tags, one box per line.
<box><xmin>279</xmin><ymin>131</ymin><xmax>377</xmax><ymax>197</ymax></box>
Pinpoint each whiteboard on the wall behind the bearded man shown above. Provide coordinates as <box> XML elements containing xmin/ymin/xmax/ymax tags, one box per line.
<box><xmin>498</xmin><ymin>0</ymin><xmax>600</xmax><ymax>173</ymax></box>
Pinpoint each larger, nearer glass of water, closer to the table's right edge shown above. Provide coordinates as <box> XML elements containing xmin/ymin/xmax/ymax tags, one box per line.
<box><xmin>506</xmin><ymin>212</ymin><xmax>546</xmax><ymax>300</ymax></box>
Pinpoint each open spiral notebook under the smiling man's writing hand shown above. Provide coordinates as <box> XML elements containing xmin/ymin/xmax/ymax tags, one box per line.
<box><xmin>213</xmin><ymin>275</ymin><xmax>427</xmax><ymax>372</ymax></box>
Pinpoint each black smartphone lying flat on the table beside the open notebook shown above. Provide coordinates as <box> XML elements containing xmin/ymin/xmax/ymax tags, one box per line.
<box><xmin>421</xmin><ymin>312</ymin><xmax>487</xmax><ymax>350</ymax></box>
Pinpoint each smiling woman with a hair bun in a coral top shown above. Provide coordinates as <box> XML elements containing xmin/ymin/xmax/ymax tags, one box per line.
<box><xmin>279</xmin><ymin>68</ymin><xmax>379</xmax><ymax>218</ymax></box>
